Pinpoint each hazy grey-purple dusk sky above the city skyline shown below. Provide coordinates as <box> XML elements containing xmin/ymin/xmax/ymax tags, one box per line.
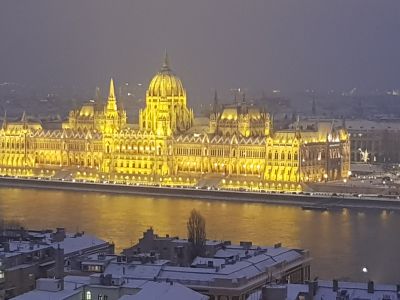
<box><xmin>0</xmin><ymin>0</ymin><xmax>400</xmax><ymax>102</ymax></box>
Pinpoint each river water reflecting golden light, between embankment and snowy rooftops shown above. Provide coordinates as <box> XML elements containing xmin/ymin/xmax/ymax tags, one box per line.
<box><xmin>0</xmin><ymin>188</ymin><xmax>400</xmax><ymax>283</ymax></box>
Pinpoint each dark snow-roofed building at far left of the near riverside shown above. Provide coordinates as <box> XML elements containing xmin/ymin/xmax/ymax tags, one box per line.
<box><xmin>0</xmin><ymin>228</ymin><xmax>114</xmax><ymax>299</ymax></box>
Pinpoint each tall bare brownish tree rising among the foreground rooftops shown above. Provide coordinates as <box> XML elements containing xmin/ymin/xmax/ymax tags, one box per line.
<box><xmin>187</xmin><ymin>209</ymin><xmax>206</xmax><ymax>259</ymax></box>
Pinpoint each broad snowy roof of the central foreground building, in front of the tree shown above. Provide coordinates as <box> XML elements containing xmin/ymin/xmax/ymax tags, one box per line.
<box><xmin>104</xmin><ymin>246</ymin><xmax>308</xmax><ymax>286</ymax></box>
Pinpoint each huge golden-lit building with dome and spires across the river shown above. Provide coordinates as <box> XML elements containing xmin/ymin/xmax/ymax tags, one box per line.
<box><xmin>0</xmin><ymin>54</ymin><xmax>350</xmax><ymax>191</ymax></box>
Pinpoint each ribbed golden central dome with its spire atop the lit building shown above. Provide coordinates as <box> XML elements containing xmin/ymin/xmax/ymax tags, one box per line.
<box><xmin>147</xmin><ymin>54</ymin><xmax>185</xmax><ymax>97</ymax></box>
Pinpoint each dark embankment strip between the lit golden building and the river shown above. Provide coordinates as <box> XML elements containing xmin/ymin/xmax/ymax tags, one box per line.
<box><xmin>0</xmin><ymin>177</ymin><xmax>400</xmax><ymax>211</ymax></box>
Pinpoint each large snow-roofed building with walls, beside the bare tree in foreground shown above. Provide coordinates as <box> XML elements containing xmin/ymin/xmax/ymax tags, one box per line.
<box><xmin>118</xmin><ymin>229</ymin><xmax>311</xmax><ymax>299</ymax></box>
